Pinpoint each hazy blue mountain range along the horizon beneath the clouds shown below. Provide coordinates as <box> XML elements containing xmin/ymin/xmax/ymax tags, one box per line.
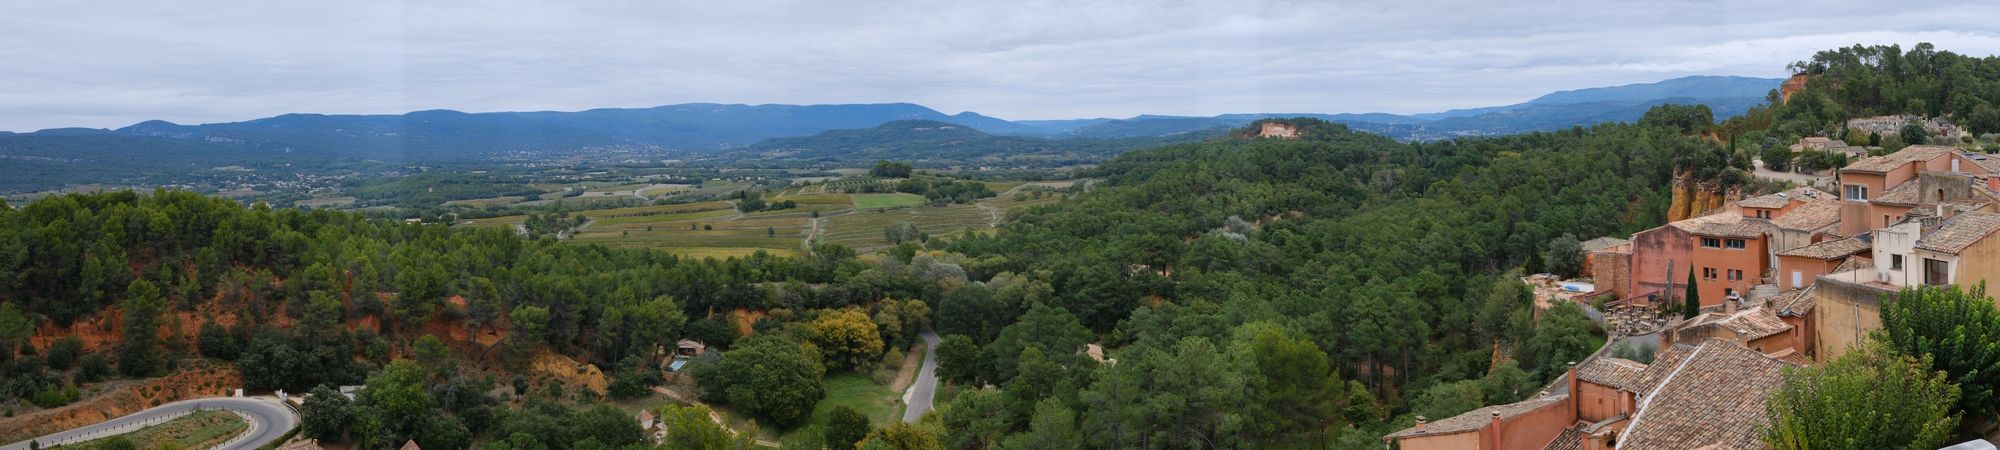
<box><xmin>0</xmin><ymin>76</ymin><xmax>1782</xmax><ymax>190</ymax></box>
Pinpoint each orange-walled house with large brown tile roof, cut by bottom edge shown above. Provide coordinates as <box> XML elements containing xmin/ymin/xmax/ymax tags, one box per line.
<box><xmin>1382</xmin><ymin>340</ymin><xmax>1790</xmax><ymax>450</ymax></box>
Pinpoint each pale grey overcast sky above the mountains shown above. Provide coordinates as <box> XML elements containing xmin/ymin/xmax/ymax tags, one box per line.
<box><xmin>0</xmin><ymin>0</ymin><xmax>2000</xmax><ymax>132</ymax></box>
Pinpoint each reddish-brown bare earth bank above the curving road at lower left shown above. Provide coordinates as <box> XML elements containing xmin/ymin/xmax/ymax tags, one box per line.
<box><xmin>0</xmin><ymin>366</ymin><xmax>244</xmax><ymax>442</ymax></box>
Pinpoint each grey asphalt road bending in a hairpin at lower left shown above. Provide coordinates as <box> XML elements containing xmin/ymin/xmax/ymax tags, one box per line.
<box><xmin>0</xmin><ymin>398</ymin><xmax>298</xmax><ymax>450</ymax></box>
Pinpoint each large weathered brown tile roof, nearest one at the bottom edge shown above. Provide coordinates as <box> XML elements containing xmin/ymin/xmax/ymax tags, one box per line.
<box><xmin>1618</xmin><ymin>340</ymin><xmax>1786</xmax><ymax>448</ymax></box>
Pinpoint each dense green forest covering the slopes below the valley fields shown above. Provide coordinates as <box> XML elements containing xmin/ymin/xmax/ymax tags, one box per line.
<box><xmin>0</xmin><ymin>111</ymin><xmax>1722</xmax><ymax>448</ymax></box>
